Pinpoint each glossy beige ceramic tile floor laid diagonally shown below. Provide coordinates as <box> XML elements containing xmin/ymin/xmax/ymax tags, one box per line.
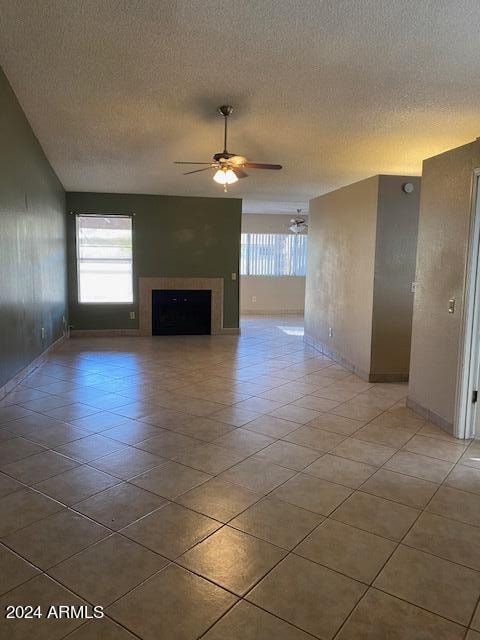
<box><xmin>0</xmin><ymin>318</ymin><xmax>480</xmax><ymax>640</ymax></box>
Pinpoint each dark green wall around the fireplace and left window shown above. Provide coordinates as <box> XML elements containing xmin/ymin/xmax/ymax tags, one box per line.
<box><xmin>67</xmin><ymin>192</ymin><xmax>242</xmax><ymax>330</ymax></box>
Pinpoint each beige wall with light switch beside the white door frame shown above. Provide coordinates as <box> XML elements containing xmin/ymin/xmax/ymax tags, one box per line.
<box><xmin>408</xmin><ymin>141</ymin><xmax>480</xmax><ymax>429</ymax></box>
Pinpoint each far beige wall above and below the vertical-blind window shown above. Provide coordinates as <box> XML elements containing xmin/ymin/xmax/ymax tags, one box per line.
<box><xmin>240</xmin><ymin>213</ymin><xmax>308</xmax><ymax>314</ymax></box>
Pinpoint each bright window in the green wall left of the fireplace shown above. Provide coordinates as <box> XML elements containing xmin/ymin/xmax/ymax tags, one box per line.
<box><xmin>77</xmin><ymin>215</ymin><xmax>133</xmax><ymax>303</ymax></box>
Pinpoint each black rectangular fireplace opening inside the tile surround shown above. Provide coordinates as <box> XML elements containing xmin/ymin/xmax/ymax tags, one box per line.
<box><xmin>152</xmin><ymin>289</ymin><xmax>212</xmax><ymax>336</ymax></box>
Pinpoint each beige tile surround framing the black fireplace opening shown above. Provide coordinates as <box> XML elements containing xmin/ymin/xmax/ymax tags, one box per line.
<box><xmin>138</xmin><ymin>277</ymin><xmax>234</xmax><ymax>336</ymax></box>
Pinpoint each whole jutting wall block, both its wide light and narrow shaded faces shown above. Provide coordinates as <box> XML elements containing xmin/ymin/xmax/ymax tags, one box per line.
<box><xmin>305</xmin><ymin>175</ymin><xmax>420</xmax><ymax>380</ymax></box>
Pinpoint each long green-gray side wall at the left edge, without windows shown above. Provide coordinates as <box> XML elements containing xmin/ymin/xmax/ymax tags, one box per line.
<box><xmin>0</xmin><ymin>69</ymin><xmax>66</xmax><ymax>387</ymax></box>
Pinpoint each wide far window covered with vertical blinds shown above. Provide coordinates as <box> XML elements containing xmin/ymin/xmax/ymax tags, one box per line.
<box><xmin>240</xmin><ymin>233</ymin><xmax>307</xmax><ymax>276</ymax></box>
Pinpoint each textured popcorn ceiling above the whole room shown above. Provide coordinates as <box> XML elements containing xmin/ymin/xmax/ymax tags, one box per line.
<box><xmin>0</xmin><ymin>0</ymin><xmax>480</xmax><ymax>202</ymax></box>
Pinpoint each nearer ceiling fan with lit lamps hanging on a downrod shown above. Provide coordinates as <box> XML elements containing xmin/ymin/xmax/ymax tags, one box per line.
<box><xmin>174</xmin><ymin>104</ymin><xmax>282</xmax><ymax>191</ymax></box>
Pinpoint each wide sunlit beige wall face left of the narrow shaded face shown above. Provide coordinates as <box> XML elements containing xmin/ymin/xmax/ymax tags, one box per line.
<box><xmin>305</xmin><ymin>176</ymin><xmax>378</xmax><ymax>374</ymax></box>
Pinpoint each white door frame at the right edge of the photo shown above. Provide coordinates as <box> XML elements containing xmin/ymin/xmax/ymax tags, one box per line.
<box><xmin>454</xmin><ymin>167</ymin><xmax>480</xmax><ymax>438</ymax></box>
